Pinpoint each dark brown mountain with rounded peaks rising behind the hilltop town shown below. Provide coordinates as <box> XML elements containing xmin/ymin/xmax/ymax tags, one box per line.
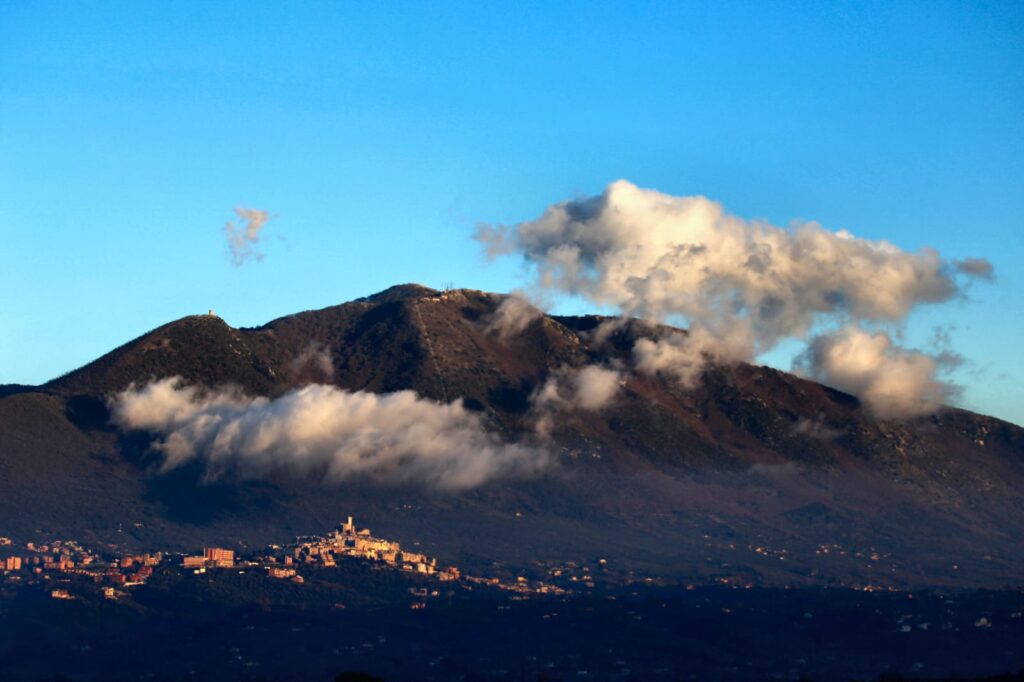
<box><xmin>0</xmin><ymin>285</ymin><xmax>1024</xmax><ymax>587</ymax></box>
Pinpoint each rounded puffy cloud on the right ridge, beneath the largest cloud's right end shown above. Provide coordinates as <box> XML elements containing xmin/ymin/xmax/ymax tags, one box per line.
<box><xmin>800</xmin><ymin>327</ymin><xmax>956</xmax><ymax>419</ymax></box>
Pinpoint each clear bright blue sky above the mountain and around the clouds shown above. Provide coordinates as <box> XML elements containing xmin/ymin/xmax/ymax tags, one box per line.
<box><xmin>0</xmin><ymin>1</ymin><xmax>1024</xmax><ymax>423</ymax></box>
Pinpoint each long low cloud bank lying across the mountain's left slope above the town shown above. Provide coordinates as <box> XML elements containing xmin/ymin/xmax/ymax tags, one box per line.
<box><xmin>111</xmin><ymin>377</ymin><xmax>550</xmax><ymax>491</ymax></box>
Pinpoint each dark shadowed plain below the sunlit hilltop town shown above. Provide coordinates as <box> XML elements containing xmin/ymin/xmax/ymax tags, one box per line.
<box><xmin>0</xmin><ymin>565</ymin><xmax>1024</xmax><ymax>681</ymax></box>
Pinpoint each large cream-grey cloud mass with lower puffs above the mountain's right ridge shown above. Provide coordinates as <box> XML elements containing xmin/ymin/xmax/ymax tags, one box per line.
<box><xmin>476</xmin><ymin>180</ymin><xmax>994</xmax><ymax>417</ymax></box>
